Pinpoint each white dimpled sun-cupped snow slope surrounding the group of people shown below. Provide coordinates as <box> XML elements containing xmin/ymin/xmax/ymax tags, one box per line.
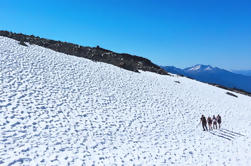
<box><xmin>0</xmin><ymin>37</ymin><xmax>251</xmax><ymax>166</ymax></box>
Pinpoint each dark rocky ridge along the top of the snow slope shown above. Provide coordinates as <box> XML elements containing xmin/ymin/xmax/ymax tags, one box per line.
<box><xmin>0</xmin><ymin>31</ymin><xmax>168</xmax><ymax>75</ymax></box>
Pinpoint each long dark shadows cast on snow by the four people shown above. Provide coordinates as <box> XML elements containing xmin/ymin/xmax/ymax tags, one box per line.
<box><xmin>209</xmin><ymin>129</ymin><xmax>245</xmax><ymax>141</ymax></box>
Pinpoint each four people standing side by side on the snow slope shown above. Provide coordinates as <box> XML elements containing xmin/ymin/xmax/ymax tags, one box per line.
<box><xmin>200</xmin><ymin>115</ymin><xmax>221</xmax><ymax>131</ymax></box>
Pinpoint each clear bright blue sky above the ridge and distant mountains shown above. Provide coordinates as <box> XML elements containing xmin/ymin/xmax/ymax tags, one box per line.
<box><xmin>0</xmin><ymin>0</ymin><xmax>251</xmax><ymax>69</ymax></box>
